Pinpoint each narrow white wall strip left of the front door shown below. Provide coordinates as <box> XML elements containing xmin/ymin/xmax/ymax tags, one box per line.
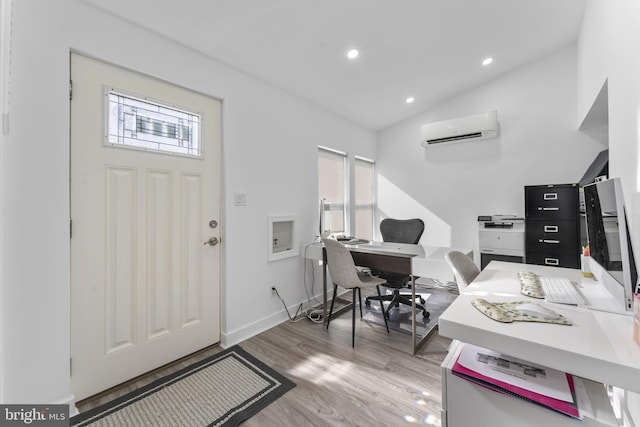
<box><xmin>1</xmin><ymin>1</ymin><xmax>70</xmax><ymax>403</ymax></box>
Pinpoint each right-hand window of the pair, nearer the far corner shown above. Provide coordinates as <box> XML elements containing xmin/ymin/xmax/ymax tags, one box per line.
<box><xmin>355</xmin><ymin>157</ymin><xmax>375</xmax><ymax>240</ymax></box>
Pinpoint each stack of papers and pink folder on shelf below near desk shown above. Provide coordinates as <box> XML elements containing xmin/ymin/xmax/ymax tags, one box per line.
<box><xmin>452</xmin><ymin>344</ymin><xmax>582</xmax><ymax>419</ymax></box>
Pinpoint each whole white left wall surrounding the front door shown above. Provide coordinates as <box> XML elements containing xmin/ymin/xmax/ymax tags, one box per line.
<box><xmin>0</xmin><ymin>0</ymin><xmax>376</xmax><ymax>403</ymax></box>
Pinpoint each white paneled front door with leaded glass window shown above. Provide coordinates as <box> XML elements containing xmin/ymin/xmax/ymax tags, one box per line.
<box><xmin>70</xmin><ymin>54</ymin><xmax>221</xmax><ymax>400</ymax></box>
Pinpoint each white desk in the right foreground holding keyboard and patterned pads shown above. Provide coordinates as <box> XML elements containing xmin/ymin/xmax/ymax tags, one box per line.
<box><xmin>438</xmin><ymin>261</ymin><xmax>640</xmax><ymax>425</ymax></box>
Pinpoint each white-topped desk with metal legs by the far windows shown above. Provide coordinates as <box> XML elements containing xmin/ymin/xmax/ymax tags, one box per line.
<box><xmin>301</xmin><ymin>242</ymin><xmax>473</xmax><ymax>354</ymax></box>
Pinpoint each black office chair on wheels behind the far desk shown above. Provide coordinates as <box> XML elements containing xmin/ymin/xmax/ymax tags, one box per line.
<box><xmin>365</xmin><ymin>218</ymin><xmax>429</xmax><ymax>319</ymax></box>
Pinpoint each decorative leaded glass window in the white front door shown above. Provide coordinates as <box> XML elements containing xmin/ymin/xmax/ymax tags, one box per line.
<box><xmin>106</xmin><ymin>90</ymin><xmax>203</xmax><ymax>157</ymax></box>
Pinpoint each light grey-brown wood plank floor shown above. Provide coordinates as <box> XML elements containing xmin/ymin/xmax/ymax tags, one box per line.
<box><xmin>78</xmin><ymin>313</ymin><xmax>451</xmax><ymax>427</ymax></box>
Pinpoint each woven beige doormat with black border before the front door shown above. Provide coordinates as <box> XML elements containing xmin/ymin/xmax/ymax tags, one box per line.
<box><xmin>71</xmin><ymin>346</ymin><xmax>295</xmax><ymax>427</ymax></box>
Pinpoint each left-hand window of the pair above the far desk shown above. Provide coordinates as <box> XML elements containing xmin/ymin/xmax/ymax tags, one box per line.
<box><xmin>318</xmin><ymin>147</ymin><xmax>347</xmax><ymax>234</ymax></box>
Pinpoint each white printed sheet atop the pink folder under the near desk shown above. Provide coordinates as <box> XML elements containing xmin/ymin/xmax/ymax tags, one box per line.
<box><xmin>458</xmin><ymin>344</ymin><xmax>573</xmax><ymax>402</ymax></box>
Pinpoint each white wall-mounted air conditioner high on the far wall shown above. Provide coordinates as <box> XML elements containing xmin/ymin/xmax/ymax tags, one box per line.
<box><xmin>421</xmin><ymin>111</ymin><xmax>498</xmax><ymax>147</ymax></box>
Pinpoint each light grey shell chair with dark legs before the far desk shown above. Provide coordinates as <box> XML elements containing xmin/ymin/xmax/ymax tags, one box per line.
<box><xmin>322</xmin><ymin>239</ymin><xmax>389</xmax><ymax>347</ymax></box>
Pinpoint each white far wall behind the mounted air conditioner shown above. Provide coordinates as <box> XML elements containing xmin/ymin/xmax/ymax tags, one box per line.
<box><xmin>378</xmin><ymin>46</ymin><xmax>606</xmax><ymax>259</ymax></box>
